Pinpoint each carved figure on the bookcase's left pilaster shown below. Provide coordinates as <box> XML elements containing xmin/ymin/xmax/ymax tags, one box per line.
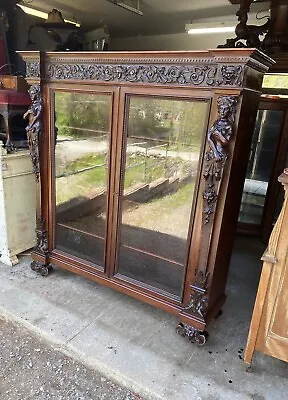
<box><xmin>23</xmin><ymin>85</ymin><xmax>42</xmax><ymax>182</ymax></box>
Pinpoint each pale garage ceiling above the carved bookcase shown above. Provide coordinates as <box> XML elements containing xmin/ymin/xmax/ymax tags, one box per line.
<box><xmin>22</xmin><ymin>0</ymin><xmax>269</xmax><ymax>36</ymax></box>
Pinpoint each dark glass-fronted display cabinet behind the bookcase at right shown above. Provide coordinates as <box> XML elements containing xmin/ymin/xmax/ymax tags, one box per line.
<box><xmin>238</xmin><ymin>96</ymin><xmax>288</xmax><ymax>242</ymax></box>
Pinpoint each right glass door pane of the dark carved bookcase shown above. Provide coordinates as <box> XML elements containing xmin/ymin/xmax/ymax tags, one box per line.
<box><xmin>118</xmin><ymin>96</ymin><xmax>209</xmax><ymax>296</ymax></box>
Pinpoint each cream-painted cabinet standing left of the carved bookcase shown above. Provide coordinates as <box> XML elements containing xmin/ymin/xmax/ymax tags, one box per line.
<box><xmin>0</xmin><ymin>145</ymin><xmax>36</xmax><ymax>265</ymax></box>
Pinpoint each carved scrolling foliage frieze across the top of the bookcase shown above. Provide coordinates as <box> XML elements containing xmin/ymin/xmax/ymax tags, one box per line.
<box><xmin>26</xmin><ymin>60</ymin><xmax>244</xmax><ymax>87</ymax></box>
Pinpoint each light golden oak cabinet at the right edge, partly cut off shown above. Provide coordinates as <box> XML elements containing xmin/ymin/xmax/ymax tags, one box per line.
<box><xmin>244</xmin><ymin>169</ymin><xmax>288</xmax><ymax>364</ymax></box>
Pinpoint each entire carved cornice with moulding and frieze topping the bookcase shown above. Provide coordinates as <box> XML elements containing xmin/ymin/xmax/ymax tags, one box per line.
<box><xmin>19</xmin><ymin>49</ymin><xmax>273</xmax><ymax>90</ymax></box>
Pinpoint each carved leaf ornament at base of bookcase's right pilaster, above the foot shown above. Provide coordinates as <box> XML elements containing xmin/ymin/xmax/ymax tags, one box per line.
<box><xmin>184</xmin><ymin>271</ymin><xmax>209</xmax><ymax>318</ymax></box>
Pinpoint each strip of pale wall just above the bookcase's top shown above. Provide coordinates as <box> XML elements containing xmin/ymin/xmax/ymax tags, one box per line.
<box><xmin>109</xmin><ymin>33</ymin><xmax>233</xmax><ymax>51</ymax></box>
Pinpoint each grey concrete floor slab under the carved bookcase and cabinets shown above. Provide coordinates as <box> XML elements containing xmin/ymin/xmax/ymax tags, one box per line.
<box><xmin>0</xmin><ymin>237</ymin><xmax>288</xmax><ymax>400</ymax></box>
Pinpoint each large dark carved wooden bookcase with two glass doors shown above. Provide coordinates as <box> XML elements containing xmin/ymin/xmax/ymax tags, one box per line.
<box><xmin>21</xmin><ymin>49</ymin><xmax>272</xmax><ymax>344</ymax></box>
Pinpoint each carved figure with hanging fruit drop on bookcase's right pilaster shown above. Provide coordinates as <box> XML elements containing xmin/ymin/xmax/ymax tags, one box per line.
<box><xmin>202</xmin><ymin>96</ymin><xmax>237</xmax><ymax>224</ymax></box>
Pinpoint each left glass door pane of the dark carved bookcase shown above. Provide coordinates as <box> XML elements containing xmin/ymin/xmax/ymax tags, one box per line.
<box><xmin>55</xmin><ymin>91</ymin><xmax>111</xmax><ymax>267</ymax></box>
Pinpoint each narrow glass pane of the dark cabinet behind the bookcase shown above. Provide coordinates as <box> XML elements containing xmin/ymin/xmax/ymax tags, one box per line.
<box><xmin>238</xmin><ymin>110</ymin><xmax>283</xmax><ymax>225</ymax></box>
